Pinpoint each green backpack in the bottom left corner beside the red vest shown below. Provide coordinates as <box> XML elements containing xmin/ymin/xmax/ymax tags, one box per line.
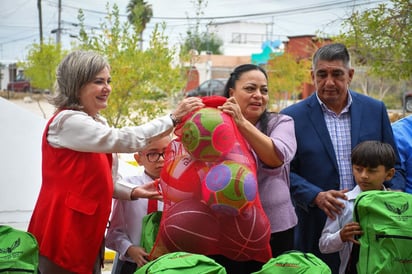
<box><xmin>0</xmin><ymin>225</ymin><xmax>39</xmax><ymax>273</ymax></box>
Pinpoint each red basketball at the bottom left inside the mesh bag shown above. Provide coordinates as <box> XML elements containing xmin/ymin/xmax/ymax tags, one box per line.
<box><xmin>159</xmin><ymin>200</ymin><xmax>219</xmax><ymax>254</ymax></box>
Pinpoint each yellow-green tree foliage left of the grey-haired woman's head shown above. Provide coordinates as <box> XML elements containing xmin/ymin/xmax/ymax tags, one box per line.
<box><xmin>18</xmin><ymin>39</ymin><xmax>67</xmax><ymax>93</ymax></box>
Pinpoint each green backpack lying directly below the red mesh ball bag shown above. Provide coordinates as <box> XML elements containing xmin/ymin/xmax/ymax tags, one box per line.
<box><xmin>135</xmin><ymin>251</ymin><xmax>226</xmax><ymax>274</ymax></box>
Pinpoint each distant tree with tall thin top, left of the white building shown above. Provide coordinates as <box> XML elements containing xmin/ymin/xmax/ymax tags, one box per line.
<box><xmin>180</xmin><ymin>0</ymin><xmax>223</xmax><ymax>55</ymax></box>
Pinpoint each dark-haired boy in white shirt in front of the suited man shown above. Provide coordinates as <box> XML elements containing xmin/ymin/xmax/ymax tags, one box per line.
<box><xmin>319</xmin><ymin>141</ymin><xmax>396</xmax><ymax>274</ymax></box>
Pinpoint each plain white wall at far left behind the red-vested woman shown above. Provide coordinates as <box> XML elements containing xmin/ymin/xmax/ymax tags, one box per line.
<box><xmin>0</xmin><ymin>97</ymin><xmax>46</xmax><ymax>224</ymax></box>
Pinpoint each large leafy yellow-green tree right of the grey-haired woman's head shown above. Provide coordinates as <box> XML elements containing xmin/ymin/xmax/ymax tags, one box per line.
<box><xmin>78</xmin><ymin>5</ymin><xmax>184</xmax><ymax>127</ymax></box>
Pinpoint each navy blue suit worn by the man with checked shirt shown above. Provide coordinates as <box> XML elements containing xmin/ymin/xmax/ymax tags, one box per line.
<box><xmin>281</xmin><ymin>91</ymin><xmax>405</xmax><ymax>272</ymax></box>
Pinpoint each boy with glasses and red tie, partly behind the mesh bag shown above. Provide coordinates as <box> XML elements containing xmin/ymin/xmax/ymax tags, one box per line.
<box><xmin>106</xmin><ymin>136</ymin><xmax>171</xmax><ymax>274</ymax></box>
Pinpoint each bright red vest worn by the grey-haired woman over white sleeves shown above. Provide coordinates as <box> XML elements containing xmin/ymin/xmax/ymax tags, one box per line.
<box><xmin>28</xmin><ymin>112</ymin><xmax>113</xmax><ymax>273</ymax></box>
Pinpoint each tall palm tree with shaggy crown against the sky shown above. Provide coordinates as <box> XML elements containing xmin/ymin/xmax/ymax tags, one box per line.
<box><xmin>127</xmin><ymin>0</ymin><xmax>153</xmax><ymax>49</ymax></box>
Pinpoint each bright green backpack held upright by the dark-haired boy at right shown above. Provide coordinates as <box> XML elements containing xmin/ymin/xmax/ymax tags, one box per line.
<box><xmin>353</xmin><ymin>190</ymin><xmax>412</xmax><ymax>274</ymax></box>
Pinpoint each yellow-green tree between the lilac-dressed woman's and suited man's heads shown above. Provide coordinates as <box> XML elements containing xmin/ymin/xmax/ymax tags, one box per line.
<box><xmin>266</xmin><ymin>53</ymin><xmax>311</xmax><ymax>108</ymax></box>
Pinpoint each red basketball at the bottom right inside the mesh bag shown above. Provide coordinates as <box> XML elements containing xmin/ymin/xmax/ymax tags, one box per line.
<box><xmin>219</xmin><ymin>205</ymin><xmax>272</xmax><ymax>262</ymax></box>
